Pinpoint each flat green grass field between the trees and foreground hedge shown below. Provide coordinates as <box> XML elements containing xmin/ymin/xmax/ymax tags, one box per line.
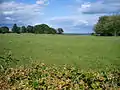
<box><xmin>0</xmin><ymin>34</ymin><xmax>120</xmax><ymax>69</ymax></box>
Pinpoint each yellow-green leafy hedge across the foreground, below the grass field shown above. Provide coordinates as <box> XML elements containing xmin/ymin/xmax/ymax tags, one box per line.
<box><xmin>0</xmin><ymin>54</ymin><xmax>120</xmax><ymax>90</ymax></box>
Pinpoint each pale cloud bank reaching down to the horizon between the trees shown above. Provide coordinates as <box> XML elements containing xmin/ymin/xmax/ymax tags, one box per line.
<box><xmin>49</xmin><ymin>14</ymin><xmax>99</xmax><ymax>32</ymax></box>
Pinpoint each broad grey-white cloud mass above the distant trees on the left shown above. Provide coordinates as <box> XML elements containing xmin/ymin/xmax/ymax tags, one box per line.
<box><xmin>0</xmin><ymin>1</ymin><xmax>45</xmax><ymax>25</ymax></box>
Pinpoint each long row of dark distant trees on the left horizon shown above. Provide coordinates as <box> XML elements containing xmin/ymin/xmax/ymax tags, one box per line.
<box><xmin>0</xmin><ymin>24</ymin><xmax>64</xmax><ymax>34</ymax></box>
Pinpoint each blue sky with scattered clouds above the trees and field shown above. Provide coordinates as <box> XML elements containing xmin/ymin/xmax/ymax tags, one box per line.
<box><xmin>0</xmin><ymin>0</ymin><xmax>120</xmax><ymax>33</ymax></box>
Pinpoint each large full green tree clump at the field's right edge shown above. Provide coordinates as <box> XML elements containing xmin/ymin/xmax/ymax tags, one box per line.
<box><xmin>94</xmin><ymin>15</ymin><xmax>120</xmax><ymax>36</ymax></box>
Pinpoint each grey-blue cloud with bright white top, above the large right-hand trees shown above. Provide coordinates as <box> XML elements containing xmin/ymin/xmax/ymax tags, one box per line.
<box><xmin>78</xmin><ymin>0</ymin><xmax>120</xmax><ymax>14</ymax></box>
